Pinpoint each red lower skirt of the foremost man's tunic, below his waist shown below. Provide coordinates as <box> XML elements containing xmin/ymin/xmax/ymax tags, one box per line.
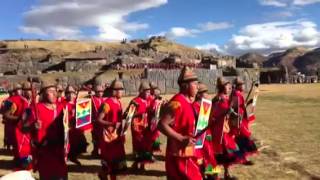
<box><xmin>165</xmin><ymin>155</ymin><xmax>202</xmax><ymax>180</ymax></box>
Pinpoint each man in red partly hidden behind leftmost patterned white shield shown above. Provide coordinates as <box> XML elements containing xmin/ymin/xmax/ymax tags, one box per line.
<box><xmin>65</xmin><ymin>85</ymin><xmax>88</xmax><ymax>165</ymax></box>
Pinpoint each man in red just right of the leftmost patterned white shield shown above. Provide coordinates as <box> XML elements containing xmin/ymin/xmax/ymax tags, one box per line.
<box><xmin>91</xmin><ymin>84</ymin><xmax>104</xmax><ymax>157</ymax></box>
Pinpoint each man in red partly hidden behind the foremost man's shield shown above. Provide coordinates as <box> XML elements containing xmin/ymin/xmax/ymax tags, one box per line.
<box><xmin>193</xmin><ymin>83</ymin><xmax>219</xmax><ymax>180</ymax></box>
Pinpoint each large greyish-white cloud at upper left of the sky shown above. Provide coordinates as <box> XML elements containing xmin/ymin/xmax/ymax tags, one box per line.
<box><xmin>20</xmin><ymin>0</ymin><xmax>167</xmax><ymax>40</ymax></box>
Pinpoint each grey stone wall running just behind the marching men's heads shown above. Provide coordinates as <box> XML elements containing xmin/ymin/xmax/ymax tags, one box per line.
<box><xmin>0</xmin><ymin>68</ymin><xmax>259</xmax><ymax>96</ymax></box>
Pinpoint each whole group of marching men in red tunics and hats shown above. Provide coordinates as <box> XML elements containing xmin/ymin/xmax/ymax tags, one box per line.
<box><xmin>1</xmin><ymin>67</ymin><xmax>257</xmax><ymax>180</ymax></box>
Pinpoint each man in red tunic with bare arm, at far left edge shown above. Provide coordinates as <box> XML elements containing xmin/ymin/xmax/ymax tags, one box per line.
<box><xmin>4</xmin><ymin>83</ymin><xmax>32</xmax><ymax>170</ymax></box>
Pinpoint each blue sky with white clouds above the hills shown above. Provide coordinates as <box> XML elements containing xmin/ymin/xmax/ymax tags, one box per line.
<box><xmin>0</xmin><ymin>0</ymin><xmax>320</xmax><ymax>55</ymax></box>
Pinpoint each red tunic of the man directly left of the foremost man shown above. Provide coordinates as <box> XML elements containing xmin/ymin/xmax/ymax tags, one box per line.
<box><xmin>131</xmin><ymin>97</ymin><xmax>151</xmax><ymax>152</ymax></box>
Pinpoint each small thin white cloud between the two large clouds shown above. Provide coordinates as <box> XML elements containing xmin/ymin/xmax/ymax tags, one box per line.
<box><xmin>149</xmin><ymin>22</ymin><xmax>233</xmax><ymax>39</ymax></box>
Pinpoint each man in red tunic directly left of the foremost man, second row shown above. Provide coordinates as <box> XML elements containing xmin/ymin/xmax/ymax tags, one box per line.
<box><xmin>130</xmin><ymin>81</ymin><xmax>153</xmax><ymax>170</ymax></box>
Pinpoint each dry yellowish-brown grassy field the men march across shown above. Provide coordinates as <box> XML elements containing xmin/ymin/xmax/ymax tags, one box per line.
<box><xmin>0</xmin><ymin>84</ymin><xmax>320</xmax><ymax>180</ymax></box>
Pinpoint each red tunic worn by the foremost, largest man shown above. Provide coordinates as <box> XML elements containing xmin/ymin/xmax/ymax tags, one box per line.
<box><xmin>166</xmin><ymin>94</ymin><xmax>202</xmax><ymax>180</ymax></box>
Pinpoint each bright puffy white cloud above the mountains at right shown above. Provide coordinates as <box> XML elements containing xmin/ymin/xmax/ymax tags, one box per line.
<box><xmin>223</xmin><ymin>20</ymin><xmax>320</xmax><ymax>54</ymax></box>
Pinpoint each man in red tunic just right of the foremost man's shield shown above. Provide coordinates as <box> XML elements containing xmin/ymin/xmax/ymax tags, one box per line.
<box><xmin>210</xmin><ymin>77</ymin><xmax>241</xmax><ymax>179</ymax></box>
